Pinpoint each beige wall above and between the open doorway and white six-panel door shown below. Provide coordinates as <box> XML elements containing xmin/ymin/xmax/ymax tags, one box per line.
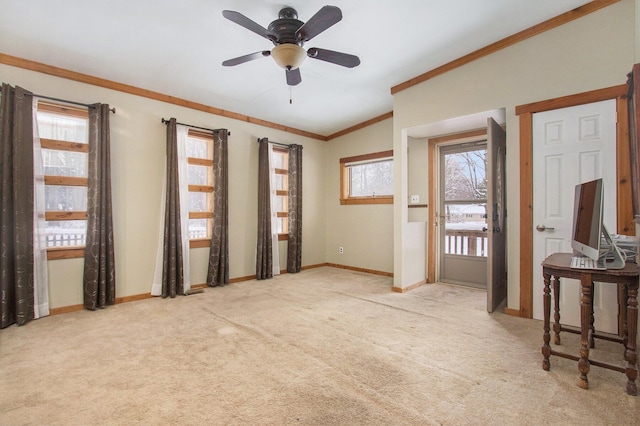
<box><xmin>393</xmin><ymin>0</ymin><xmax>637</xmax><ymax>309</ymax></box>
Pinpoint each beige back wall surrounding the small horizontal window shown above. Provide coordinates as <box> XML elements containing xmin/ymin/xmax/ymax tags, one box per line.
<box><xmin>324</xmin><ymin>119</ymin><xmax>393</xmax><ymax>272</ymax></box>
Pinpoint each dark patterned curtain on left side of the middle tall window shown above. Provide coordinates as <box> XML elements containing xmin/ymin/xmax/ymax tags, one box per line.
<box><xmin>161</xmin><ymin>118</ymin><xmax>184</xmax><ymax>297</ymax></box>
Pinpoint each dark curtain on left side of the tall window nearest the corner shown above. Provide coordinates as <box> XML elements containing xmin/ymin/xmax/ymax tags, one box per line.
<box><xmin>256</xmin><ymin>138</ymin><xmax>273</xmax><ymax>280</ymax></box>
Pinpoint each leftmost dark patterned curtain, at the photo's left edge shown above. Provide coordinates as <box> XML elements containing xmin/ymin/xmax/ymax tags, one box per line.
<box><xmin>0</xmin><ymin>84</ymin><xmax>34</xmax><ymax>328</ymax></box>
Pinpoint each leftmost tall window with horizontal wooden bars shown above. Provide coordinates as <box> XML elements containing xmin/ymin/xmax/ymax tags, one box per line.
<box><xmin>36</xmin><ymin>101</ymin><xmax>89</xmax><ymax>259</ymax></box>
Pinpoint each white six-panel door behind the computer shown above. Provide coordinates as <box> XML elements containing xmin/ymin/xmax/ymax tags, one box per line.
<box><xmin>533</xmin><ymin>100</ymin><xmax>618</xmax><ymax>333</ymax></box>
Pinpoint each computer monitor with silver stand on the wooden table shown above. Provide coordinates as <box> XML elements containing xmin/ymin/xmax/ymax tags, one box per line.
<box><xmin>571</xmin><ymin>179</ymin><xmax>625</xmax><ymax>269</ymax></box>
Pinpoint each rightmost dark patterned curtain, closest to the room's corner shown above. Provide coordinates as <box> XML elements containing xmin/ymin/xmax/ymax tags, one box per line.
<box><xmin>287</xmin><ymin>144</ymin><xmax>302</xmax><ymax>272</ymax></box>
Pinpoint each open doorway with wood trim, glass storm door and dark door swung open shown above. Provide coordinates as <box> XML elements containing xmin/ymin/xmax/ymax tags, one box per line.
<box><xmin>428</xmin><ymin>117</ymin><xmax>507</xmax><ymax>312</ymax></box>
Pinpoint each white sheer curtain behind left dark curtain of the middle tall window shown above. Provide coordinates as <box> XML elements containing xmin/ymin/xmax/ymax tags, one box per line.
<box><xmin>151</xmin><ymin>124</ymin><xmax>191</xmax><ymax>296</ymax></box>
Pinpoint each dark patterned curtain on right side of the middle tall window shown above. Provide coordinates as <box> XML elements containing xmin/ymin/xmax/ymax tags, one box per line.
<box><xmin>207</xmin><ymin>129</ymin><xmax>229</xmax><ymax>287</ymax></box>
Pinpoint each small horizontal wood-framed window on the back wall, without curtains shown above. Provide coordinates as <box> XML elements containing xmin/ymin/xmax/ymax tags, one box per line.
<box><xmin>340</xmin><ymin>151</ymin><xmax>393</xmax><ymax>204</ymax></box>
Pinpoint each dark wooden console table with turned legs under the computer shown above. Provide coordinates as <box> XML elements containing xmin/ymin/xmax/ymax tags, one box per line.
<box><xmin>542</xmin><ymin>253</ymin><xmax>639</xmax><ymax>395</ymax></box>
